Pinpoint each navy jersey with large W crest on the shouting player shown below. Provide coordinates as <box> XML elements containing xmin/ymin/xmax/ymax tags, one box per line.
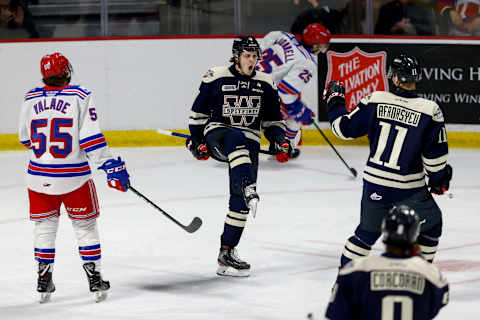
<box><xmin>188</xmin><ymin>65</ymin><xmax>285</xmax><ymax>143</ymax></box>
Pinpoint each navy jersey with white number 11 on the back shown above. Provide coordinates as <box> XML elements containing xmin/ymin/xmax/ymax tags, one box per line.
<box><xmin>328</xmin><ymin>91</ymin><xmax>448</xmax><ymax>202</ymax></box>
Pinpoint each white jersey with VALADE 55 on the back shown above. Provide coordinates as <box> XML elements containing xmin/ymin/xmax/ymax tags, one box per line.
<box><xmin>18</xmin><ymin>85</ymin><xmax>112</xmax><ymax>194</ymax></box>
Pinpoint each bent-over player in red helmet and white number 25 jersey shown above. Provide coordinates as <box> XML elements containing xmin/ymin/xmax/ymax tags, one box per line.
<box><xmin>257</xmin><ymin>23</ymin><xmax>331</xmax><ymax>162</ymax></box>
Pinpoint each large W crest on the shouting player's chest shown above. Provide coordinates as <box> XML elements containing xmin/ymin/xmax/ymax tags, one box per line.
<box><xmin>222</xmin><ymin>95</ymin><xmax>262</xmax><ymax>127</ymax></box>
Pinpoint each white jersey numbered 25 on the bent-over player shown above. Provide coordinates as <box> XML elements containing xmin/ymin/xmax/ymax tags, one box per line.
<box><xmin>257</xmin><ymin>31</ymin><xmax>317</xmax><ymax>108</ymax></box>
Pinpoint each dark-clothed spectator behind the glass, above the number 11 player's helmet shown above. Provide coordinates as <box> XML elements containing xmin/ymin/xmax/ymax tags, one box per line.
<box><xmin>375</xmin><ymin>0</ymin><xmax>434</xmax><ymax>35</ymax></box>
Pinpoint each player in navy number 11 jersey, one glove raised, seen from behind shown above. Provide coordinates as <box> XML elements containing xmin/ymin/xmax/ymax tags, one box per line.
<box><xmin>324</xmin><ymin>55</ymin><xmax>452</xmax><ymax>266</ymax></box>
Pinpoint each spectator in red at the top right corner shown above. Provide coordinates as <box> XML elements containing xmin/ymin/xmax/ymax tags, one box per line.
<box><xmin>437</xmin><ymin>0</ymin><xmax>480</xmax><ymax>36</ymax></box>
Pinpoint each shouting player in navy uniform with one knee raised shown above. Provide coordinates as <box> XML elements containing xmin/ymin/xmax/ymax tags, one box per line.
<box><xmin>187</xmin><ymin>36</ymin><xmax>293</xmax><ymax>277</ymax></box>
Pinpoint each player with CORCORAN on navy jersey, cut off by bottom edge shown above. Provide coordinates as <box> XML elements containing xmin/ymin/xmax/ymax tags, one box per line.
<box><xmin>325</xmin><ymin>205</ymin><xmax>449</xmax><ymax>320</ymax></box>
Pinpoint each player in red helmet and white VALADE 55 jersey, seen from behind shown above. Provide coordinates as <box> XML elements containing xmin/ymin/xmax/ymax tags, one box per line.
<box><xmin>19</xmin><ymin>52</ymin><xmax>130</xmax><ymax>303</ymax></box>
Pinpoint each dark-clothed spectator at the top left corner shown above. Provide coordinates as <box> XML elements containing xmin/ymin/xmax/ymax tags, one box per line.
<box><xmin>0</xmin><ymin>0</ymin><xmax>39</xmax><ymax>38</ymax></box>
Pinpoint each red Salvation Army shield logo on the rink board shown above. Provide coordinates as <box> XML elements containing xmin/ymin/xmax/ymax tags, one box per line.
<box><xmin>325</xmin><ymin>47</ymin><xmax>388</xmax><ymax>111</ymax></box>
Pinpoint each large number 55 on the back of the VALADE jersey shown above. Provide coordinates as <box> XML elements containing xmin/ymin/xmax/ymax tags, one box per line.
<box><xmin>30</xmin><ymin>118</ymin><xmax>73</xmax><ymax>158</ymax></box>
